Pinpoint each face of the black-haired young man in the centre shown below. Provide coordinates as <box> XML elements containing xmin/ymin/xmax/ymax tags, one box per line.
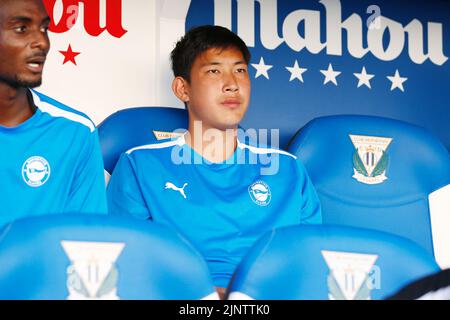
<box><xmin>185</xmin><ymin>47</ymin><xmax>250</xmax><ymax>130</ymax></box>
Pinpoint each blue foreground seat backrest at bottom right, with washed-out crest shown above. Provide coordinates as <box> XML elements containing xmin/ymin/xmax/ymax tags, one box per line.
<box><xmin>228</xmin><ymin>225</ymin><xmax>439</xmax><ymax>300</ymax></box>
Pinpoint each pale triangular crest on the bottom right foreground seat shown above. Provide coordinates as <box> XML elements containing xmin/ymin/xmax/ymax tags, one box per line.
<box><xmin>322</xmin><ymin>251</ymin><xmax>378</xmax><ymax>300</ymax></box>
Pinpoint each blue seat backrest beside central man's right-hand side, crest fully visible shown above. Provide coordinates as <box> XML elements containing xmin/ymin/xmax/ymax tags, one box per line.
<box><xmin>289</xmin><ymin>116</ymin><xmax>450</xmax><ymax>267</ymax></box>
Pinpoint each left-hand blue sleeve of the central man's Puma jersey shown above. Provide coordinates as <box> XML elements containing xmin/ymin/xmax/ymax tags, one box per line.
<box><xmin>107</xmin><ymin>153</ymin><xmax>151</xmax><ymax>220</ymax></box>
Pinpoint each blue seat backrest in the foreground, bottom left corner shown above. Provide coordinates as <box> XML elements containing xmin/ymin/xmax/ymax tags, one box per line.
<box><xmin>0</xmin><ymin>214</ymin><xmax>218</xmax><ymax>300</ymax></box>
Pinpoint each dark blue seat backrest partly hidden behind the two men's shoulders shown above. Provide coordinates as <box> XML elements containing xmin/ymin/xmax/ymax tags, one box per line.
<box><xmin>98</xmin><ymin>107</ymin><xmax>188</xmax><ymax>175</ymax></box>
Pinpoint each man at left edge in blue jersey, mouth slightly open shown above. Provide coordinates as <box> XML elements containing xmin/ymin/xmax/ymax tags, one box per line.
<box><xmin>0</xmin><ymin>0</ymin><xmax>107</xmax><ymax>227</ymax></box>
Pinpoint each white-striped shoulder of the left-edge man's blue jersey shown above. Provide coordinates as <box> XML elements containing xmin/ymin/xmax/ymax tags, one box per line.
<box><xmin>31</xmin><ymin>90</ymin><xmax>95</xmax><ymax>133</ymax></box>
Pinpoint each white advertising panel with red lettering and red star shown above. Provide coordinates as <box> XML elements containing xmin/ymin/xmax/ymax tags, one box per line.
<box><xmin>38</xmin><ymin>0</ymin><xmax>185</xmax><ymax>124</ymax></box>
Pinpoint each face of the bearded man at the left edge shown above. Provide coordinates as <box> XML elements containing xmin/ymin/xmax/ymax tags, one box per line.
<box><xmin>0</xmin><ymin>0</ymin><xmax>50</xmax><ymax>88</ymax></box>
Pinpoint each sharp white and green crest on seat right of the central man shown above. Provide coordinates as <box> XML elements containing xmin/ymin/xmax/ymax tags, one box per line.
<box><xmin>350</xmin><ymin>135</ymin><xmax>392</xmax><ymax>184</ymax></box>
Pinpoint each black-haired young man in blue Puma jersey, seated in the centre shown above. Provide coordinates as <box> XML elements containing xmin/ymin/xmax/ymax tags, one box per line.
<box><xmin>108</xmin><ymin>26</ymin><xmax>322</xmax><ymax>294</ymax></box>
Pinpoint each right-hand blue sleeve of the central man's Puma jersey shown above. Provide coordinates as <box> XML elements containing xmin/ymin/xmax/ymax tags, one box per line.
<box><xmin>296</xmin><ymin>159</ymin><xmax>322</xmax><ymax>224</ymax></box>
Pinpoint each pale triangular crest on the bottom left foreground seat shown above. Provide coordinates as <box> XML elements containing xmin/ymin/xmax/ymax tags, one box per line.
<box><xmin>61</xmin><ymin>241</ymin><xmax>125</xmax><ymax>300</ymax></box>
